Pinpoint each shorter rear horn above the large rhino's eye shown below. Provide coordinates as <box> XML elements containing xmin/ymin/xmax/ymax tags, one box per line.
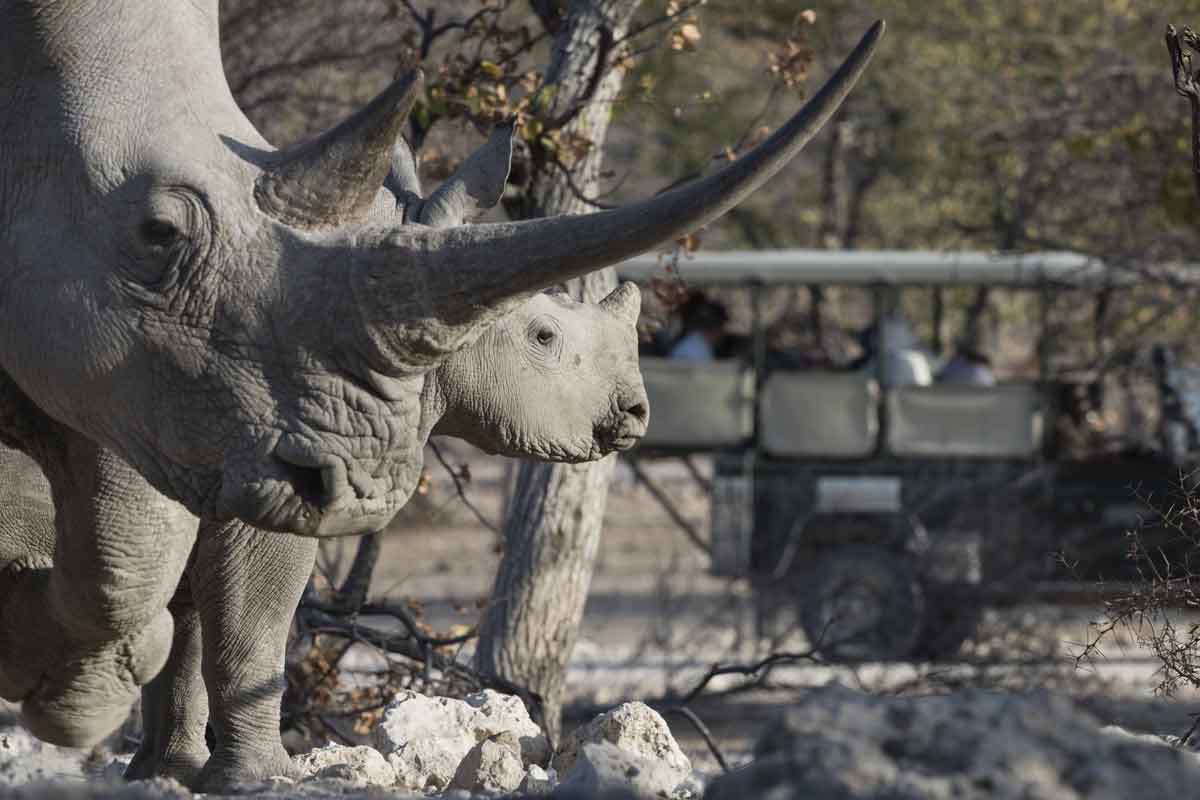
<box><xmin>254</xmin><ymin>70</ymin><xmax>424</xmax><ymax>228</ymax></box>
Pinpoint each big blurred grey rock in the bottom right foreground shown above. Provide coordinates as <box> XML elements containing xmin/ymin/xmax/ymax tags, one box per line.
<box><xmin>704</xmin><ymin>687</ymin><xmax>1200</xmax><ymax>800</ymax></box>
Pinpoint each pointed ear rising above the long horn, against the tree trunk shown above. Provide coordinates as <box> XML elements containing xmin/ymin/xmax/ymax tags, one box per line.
<box><xmin>418</xmin><ymin>125</ymin><xmax>515</xmax><ymax>228</ymax></box>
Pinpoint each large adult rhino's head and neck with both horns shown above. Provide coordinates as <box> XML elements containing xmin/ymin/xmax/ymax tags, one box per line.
<box><xmin>0</xmin><ymin>0</ymin><xmax>882</xmax><ymax>535</ymax></box>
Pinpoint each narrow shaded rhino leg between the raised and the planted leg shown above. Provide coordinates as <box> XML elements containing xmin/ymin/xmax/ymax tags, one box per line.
<box><xmin>125</xmin><ymin>585</ymin><xmax>209</xmax><ymax>784</ymax></box>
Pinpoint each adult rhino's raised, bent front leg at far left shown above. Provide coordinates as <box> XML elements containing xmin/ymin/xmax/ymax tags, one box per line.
<box><xmin>0</xmin><ymin>431</ymin><xmax>196</xmax><ymax>747</ymax></box>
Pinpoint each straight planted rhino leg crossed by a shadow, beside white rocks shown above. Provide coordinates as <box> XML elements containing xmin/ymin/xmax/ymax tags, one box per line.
<box><xmin>191</xmin><ymin>522</ymin><xmax>317</xmax><ymax>792</ymax></box>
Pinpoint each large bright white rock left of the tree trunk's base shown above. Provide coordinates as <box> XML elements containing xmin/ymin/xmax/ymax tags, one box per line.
<box><xmin>372</xmin><ymin>690</ymin><xmax>550</xmax><ymax>792</ymax></box>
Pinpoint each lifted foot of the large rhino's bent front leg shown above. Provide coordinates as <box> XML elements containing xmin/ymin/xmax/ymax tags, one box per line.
<box><xmin>22</xmin><ymin>610</ymin><xmax>174</xmax><ymax>747</ymax></box>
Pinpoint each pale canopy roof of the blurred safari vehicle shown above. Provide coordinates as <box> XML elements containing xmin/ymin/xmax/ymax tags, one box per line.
<box><xmin>617</xmin><ymin>249</ymin><xmax>1133</xmax><ymax>289</ymax></box>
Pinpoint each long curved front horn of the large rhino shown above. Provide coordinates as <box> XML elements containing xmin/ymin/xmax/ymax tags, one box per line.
<box><xmin>403</xmin><ymin>22</ymin><xmax>884</xmax><ymax>311</ymax></box>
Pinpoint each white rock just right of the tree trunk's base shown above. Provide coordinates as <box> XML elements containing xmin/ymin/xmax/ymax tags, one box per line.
<box><xmin>554</xmin><ymin>703</ymin><xmax>691</xmax><ymax>788</ymax></box>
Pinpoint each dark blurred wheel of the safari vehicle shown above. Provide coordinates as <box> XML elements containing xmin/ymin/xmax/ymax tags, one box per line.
<box><xmin>799</xmin><ymin>545</ymin><xmax>924</xmax><ymax>661</ymax></box>
